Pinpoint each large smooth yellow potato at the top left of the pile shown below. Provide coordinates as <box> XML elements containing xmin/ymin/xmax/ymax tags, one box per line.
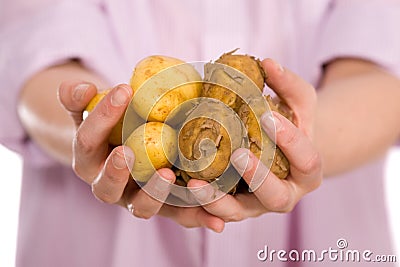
<box><xmin>130</xmin><ymin>56</ymin><xmax>202</xmax><ymax>122</ymax></box>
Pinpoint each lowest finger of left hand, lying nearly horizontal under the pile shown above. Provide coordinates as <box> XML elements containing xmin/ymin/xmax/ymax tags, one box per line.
<box><xmin>159</xmin><ymin>205</ymin><xmax>225</xmax><ymax>233</ymax></box>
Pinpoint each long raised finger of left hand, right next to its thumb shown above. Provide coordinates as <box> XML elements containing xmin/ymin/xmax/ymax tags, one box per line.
<box><xmin>73</xmin><ymin>85</ymin><xmax>132</xmax><ymax>180</ymax></box>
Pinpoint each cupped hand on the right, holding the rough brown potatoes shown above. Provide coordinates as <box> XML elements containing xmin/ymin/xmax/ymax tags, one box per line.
<box><xmin>188</xmin><ymin>59</ymin><xmax>322</xmax><ymax>222</ymax></box>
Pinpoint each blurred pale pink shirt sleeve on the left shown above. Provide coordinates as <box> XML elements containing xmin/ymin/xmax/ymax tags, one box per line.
<box><xmin>0</xmin><ymin>0</ymin><xmax>122</xmax><ymax>159</ymax></box>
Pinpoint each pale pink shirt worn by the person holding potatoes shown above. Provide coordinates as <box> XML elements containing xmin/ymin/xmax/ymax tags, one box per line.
<box><xmin>0</xmin><ymin>0</ymin><xmax>400</xmax><ymax>267</ymax></box>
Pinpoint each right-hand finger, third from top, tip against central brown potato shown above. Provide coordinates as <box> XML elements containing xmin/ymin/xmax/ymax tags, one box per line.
<box><xmin>231</xmin><ymin>148</ymin><xmax>300</xmax><ymax>212</ymax></box>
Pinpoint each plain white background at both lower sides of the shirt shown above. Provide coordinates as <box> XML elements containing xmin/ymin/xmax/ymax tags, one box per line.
<box><xmin>0</xmin><ymin>145</ymin><xmax>400</xmax><ymax>267</ymax></box>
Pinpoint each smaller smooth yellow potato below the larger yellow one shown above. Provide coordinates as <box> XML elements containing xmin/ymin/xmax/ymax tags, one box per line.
<box><xmin>125</xmin><ymin>122</ymin><xmax>178</xmax><ymax>182</ymax></box>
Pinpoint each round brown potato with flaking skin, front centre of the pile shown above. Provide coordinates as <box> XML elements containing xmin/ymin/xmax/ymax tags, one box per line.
<box><xmin>178</xmin><ymin>99</ymin><xmax>247</xmax><ymax>181</ymax></box>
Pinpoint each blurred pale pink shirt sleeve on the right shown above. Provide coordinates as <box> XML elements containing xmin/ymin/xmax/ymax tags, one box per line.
<box><xmin>317</xmin><ymin>0</ymin><xmax>400</xmax><ymax>77</ymax></box>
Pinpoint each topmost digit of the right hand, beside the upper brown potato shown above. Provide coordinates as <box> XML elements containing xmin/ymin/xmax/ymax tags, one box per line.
<box><xmin>262</xmin><ymin>59</ymin><xmax>317</xmax><ymax>134</ymax></box>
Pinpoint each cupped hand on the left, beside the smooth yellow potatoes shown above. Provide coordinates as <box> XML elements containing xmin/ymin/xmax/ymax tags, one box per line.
<box><xmin>59</xmin><ymin>81</ymin><xmax>224</xmax><ymax>232</ymax></box>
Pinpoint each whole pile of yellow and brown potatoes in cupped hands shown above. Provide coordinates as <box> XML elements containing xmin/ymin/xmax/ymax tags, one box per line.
<box><xmin>87</xmin><ymin>51</ymin><xmax>290</xmax><ymax>192</ymax></box>
